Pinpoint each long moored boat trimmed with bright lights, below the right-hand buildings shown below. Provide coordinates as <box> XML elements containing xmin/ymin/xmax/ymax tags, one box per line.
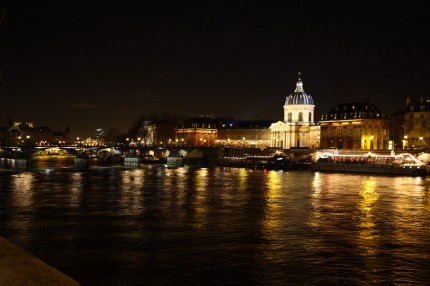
<box><xmin>311</xmin><ymin>151</ymin><xmax>426</xmax><ymax>176</ymax></box>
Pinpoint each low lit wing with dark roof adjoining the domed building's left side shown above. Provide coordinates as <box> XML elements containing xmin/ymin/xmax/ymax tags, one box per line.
<box><xmin>217</xmin><ymin>120</ymin><xmax>272</xmax><ymax>148</ymax></box>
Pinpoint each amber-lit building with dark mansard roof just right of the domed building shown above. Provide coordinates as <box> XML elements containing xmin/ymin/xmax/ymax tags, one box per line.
<box><xmin>319</xmin><ymin>102</ymin><xmax>389</xmax><ymax>150</ymax></box>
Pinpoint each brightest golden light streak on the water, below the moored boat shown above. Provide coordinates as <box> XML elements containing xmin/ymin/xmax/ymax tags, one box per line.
<box><xmin>358</xmin><ymin>177</ymin><xmax>380</xmax><ymax>255</ymax></box>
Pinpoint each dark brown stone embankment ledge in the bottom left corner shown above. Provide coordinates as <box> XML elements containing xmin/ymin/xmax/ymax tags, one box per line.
<box><xmin>0</xmin><ymin>237</ymin><xmax>79</xmax><ymax>286</ymax></box>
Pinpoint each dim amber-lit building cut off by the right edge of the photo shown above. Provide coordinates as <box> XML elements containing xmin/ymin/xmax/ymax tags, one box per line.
<box><xmin>403</xmin><ymin>97</ymin><xmax>430</xmax><ymax>148</ymax></box>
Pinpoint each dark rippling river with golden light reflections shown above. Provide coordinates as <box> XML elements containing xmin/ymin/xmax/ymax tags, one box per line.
<box><xmin>0</xmin><ymin>158</ymin><xmax>430</xmax><ymax>285</ymax></box>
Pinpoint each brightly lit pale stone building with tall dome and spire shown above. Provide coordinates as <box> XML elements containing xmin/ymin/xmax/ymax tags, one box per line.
<box><xmin>270</xmin><ymin>73</ymin><xmax>318</xmax><ymax>149</ymax></box>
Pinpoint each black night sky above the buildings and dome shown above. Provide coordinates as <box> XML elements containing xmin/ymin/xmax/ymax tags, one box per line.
<box><xmin>0</xmin><ymin>0</ymin><xmax>430</xmax><ymax>137</ymax></box>
